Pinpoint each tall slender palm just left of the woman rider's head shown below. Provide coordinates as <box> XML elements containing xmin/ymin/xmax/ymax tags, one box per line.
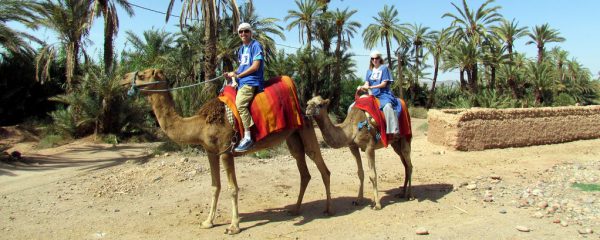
<box><xmin>331</xmin><ymin>8</ymin><xmax>361</xmax><ymax>109</ymax></box>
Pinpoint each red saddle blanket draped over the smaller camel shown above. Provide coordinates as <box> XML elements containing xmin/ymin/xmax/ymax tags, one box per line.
<box><xmin>354</xmin><ymin>95</ymin><xmax>412</xmax><ymax>147</ymax></box>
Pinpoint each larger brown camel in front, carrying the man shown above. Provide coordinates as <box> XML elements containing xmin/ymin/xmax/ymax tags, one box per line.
<box><xmin>121</xmin><ymin>69</ymin><xmax>333</xmax><ymax>234</ymax></box>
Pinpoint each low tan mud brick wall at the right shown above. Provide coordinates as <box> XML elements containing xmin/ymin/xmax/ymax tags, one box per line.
<box><xmin>427</xmin><ymin>106</ymin><xmax>600</xmax><ymax>151</ymax></box>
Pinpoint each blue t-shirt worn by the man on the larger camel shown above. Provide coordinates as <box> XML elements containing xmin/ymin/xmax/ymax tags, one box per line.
<box><xmin>236</xmin><ymin>39</ymin><xmax>265</xmax><ymax>92</ymax></box>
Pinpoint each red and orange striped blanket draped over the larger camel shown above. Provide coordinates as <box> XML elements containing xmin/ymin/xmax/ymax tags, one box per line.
<box><xmin>219</xmin><ymin>76</ymin><xmax>303</xmax><ymax>141</ymax></box>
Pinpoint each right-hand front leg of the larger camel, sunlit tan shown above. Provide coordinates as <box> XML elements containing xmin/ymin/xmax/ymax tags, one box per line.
<box><xmin>221</xmin><ymin>154</ymin><xmax>240</xmax><ymax>234</ymax></box>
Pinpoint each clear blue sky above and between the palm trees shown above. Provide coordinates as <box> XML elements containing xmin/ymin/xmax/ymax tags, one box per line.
<box><xmin>10</xmin><ymin>0</ymin><xmax>600</xmax><ymax>79</ymax></box>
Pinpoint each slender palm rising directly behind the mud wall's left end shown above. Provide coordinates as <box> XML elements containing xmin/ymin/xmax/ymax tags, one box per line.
<box><xmin>425</xmin><ymin>28</ymin><xmax>450</xmax><ymax>108</ymax></box>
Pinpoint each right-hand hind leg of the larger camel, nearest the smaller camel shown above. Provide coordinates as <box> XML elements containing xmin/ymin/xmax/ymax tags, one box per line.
<box><xmin>299</xmin><ymin>124</ymin><xmax>334</xmax><ymax>216</ymax></box>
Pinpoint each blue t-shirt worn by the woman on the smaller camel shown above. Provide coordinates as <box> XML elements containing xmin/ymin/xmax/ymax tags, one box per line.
<box><xmin>365</xmin><ymin>65</ymin><xmax>402</xmax><ymax>116</ymax></box>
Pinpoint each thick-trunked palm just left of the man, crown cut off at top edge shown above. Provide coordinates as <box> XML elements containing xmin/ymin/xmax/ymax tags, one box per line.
<box><xmin>165</xmin><ymin>0</ymin><xmax>240</xmax><ymax>97</ymax></box>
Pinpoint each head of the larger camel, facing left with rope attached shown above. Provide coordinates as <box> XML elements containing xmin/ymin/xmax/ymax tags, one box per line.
<box><xmin>120</xmin><ymin>68</ymin><xmax>169</xmax><ymax>96</ymax></box>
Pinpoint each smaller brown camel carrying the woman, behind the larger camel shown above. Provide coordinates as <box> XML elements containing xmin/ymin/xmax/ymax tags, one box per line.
<box><xmin>306</xmin><ymin>96</ymin><xmax>412</xmax><ymax>210</ymax></box>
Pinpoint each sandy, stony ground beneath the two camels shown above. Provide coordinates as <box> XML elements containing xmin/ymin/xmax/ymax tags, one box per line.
<box><xmin>0</xmin><ymin>119</ymin><xmax>600</xmax><ymax>239</ymax></box>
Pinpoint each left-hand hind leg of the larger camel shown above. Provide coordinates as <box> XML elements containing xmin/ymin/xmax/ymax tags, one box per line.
<box><xmin>286</xmin><ymin>133</ymin><xmax>310</xmax><ymax>215</ymax></box>
